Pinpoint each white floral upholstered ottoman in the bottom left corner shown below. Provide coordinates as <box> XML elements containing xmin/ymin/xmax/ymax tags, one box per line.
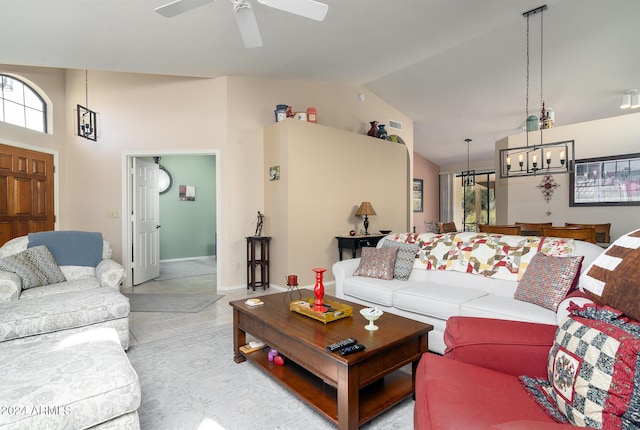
<box><xmin>0</xmin><ymin>329</ymin><xmax>141</xmax><ymax>429</ymax></box>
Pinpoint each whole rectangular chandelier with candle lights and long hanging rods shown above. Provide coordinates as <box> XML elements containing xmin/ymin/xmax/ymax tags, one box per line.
<box><xmin>500</xmin><ymin>5</ymin><xmax>574</xmax><ymax>178</ymax></box>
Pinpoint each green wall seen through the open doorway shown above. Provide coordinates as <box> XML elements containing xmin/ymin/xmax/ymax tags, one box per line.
<box><xmin>160</xmin><ymin>155</ymin><xmax>217</xmax><ymax>260</ymax></box>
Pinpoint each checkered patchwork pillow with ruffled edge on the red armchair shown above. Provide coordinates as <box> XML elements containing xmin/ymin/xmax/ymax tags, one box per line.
<box><xmin>520</xmin><ymin>304</ymin><xmax>640</xmax><ymax>429</ymax></box>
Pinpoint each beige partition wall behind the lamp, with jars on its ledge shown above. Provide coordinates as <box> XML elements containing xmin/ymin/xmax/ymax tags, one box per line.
<box><xmin>264</xmin><ymin>119</ymin><xmax>409</xmax><ymax>286</ymax></box>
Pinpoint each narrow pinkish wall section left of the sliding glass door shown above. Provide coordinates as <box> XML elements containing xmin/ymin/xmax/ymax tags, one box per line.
<box><xmin>412</xmin><ymin>153</ymin><xmax>440</xmax><ymax>233</ymax></box>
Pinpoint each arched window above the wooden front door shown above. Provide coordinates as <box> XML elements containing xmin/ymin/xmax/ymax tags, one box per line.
<box><xmin>0</xmin><ymin>74</ymin><xmax>47</xmax><ymax>133</ymax></box>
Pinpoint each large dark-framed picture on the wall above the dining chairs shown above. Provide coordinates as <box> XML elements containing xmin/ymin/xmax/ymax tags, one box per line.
<box><xmin>569</xmin><ymin>153</ymin><xmax>640</xmax><ymax>206</ymax></box>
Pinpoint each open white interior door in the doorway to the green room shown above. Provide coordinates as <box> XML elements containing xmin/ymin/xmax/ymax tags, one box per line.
<box><xmin>132</xmin><ymin>158</ymin><xmax>160</xmax><ymax>285</ymax></box>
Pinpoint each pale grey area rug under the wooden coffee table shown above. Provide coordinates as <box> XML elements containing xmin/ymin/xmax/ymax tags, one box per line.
<box><xmin>127</xmin><ymin>324</ymin><xmax>414</xmax><ymax>430</ymax></box>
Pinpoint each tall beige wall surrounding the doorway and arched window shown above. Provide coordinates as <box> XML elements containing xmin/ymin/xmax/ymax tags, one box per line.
<box><xmin>0</xmin><ymin>65</ymin><xmax>413</xmax><ymax>288</ymax></box>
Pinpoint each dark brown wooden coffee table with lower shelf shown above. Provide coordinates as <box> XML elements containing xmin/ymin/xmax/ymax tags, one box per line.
<box><xmin>229</xmin><ymin>289</ymin><xmax>433</xmax><ymax>429</ymax></box>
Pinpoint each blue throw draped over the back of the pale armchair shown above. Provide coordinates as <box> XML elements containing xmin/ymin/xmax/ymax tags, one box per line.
<box><xmin>27</xmin><ymin>231</ymin><xmax>103</xmax><ymax>267</ymax></box>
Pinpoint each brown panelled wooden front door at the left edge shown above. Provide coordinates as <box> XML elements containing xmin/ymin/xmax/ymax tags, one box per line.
<box><xmin>0</xmin><ymin>145</ymin><xmax>55</xmax><ymax>246</ymax></box>
